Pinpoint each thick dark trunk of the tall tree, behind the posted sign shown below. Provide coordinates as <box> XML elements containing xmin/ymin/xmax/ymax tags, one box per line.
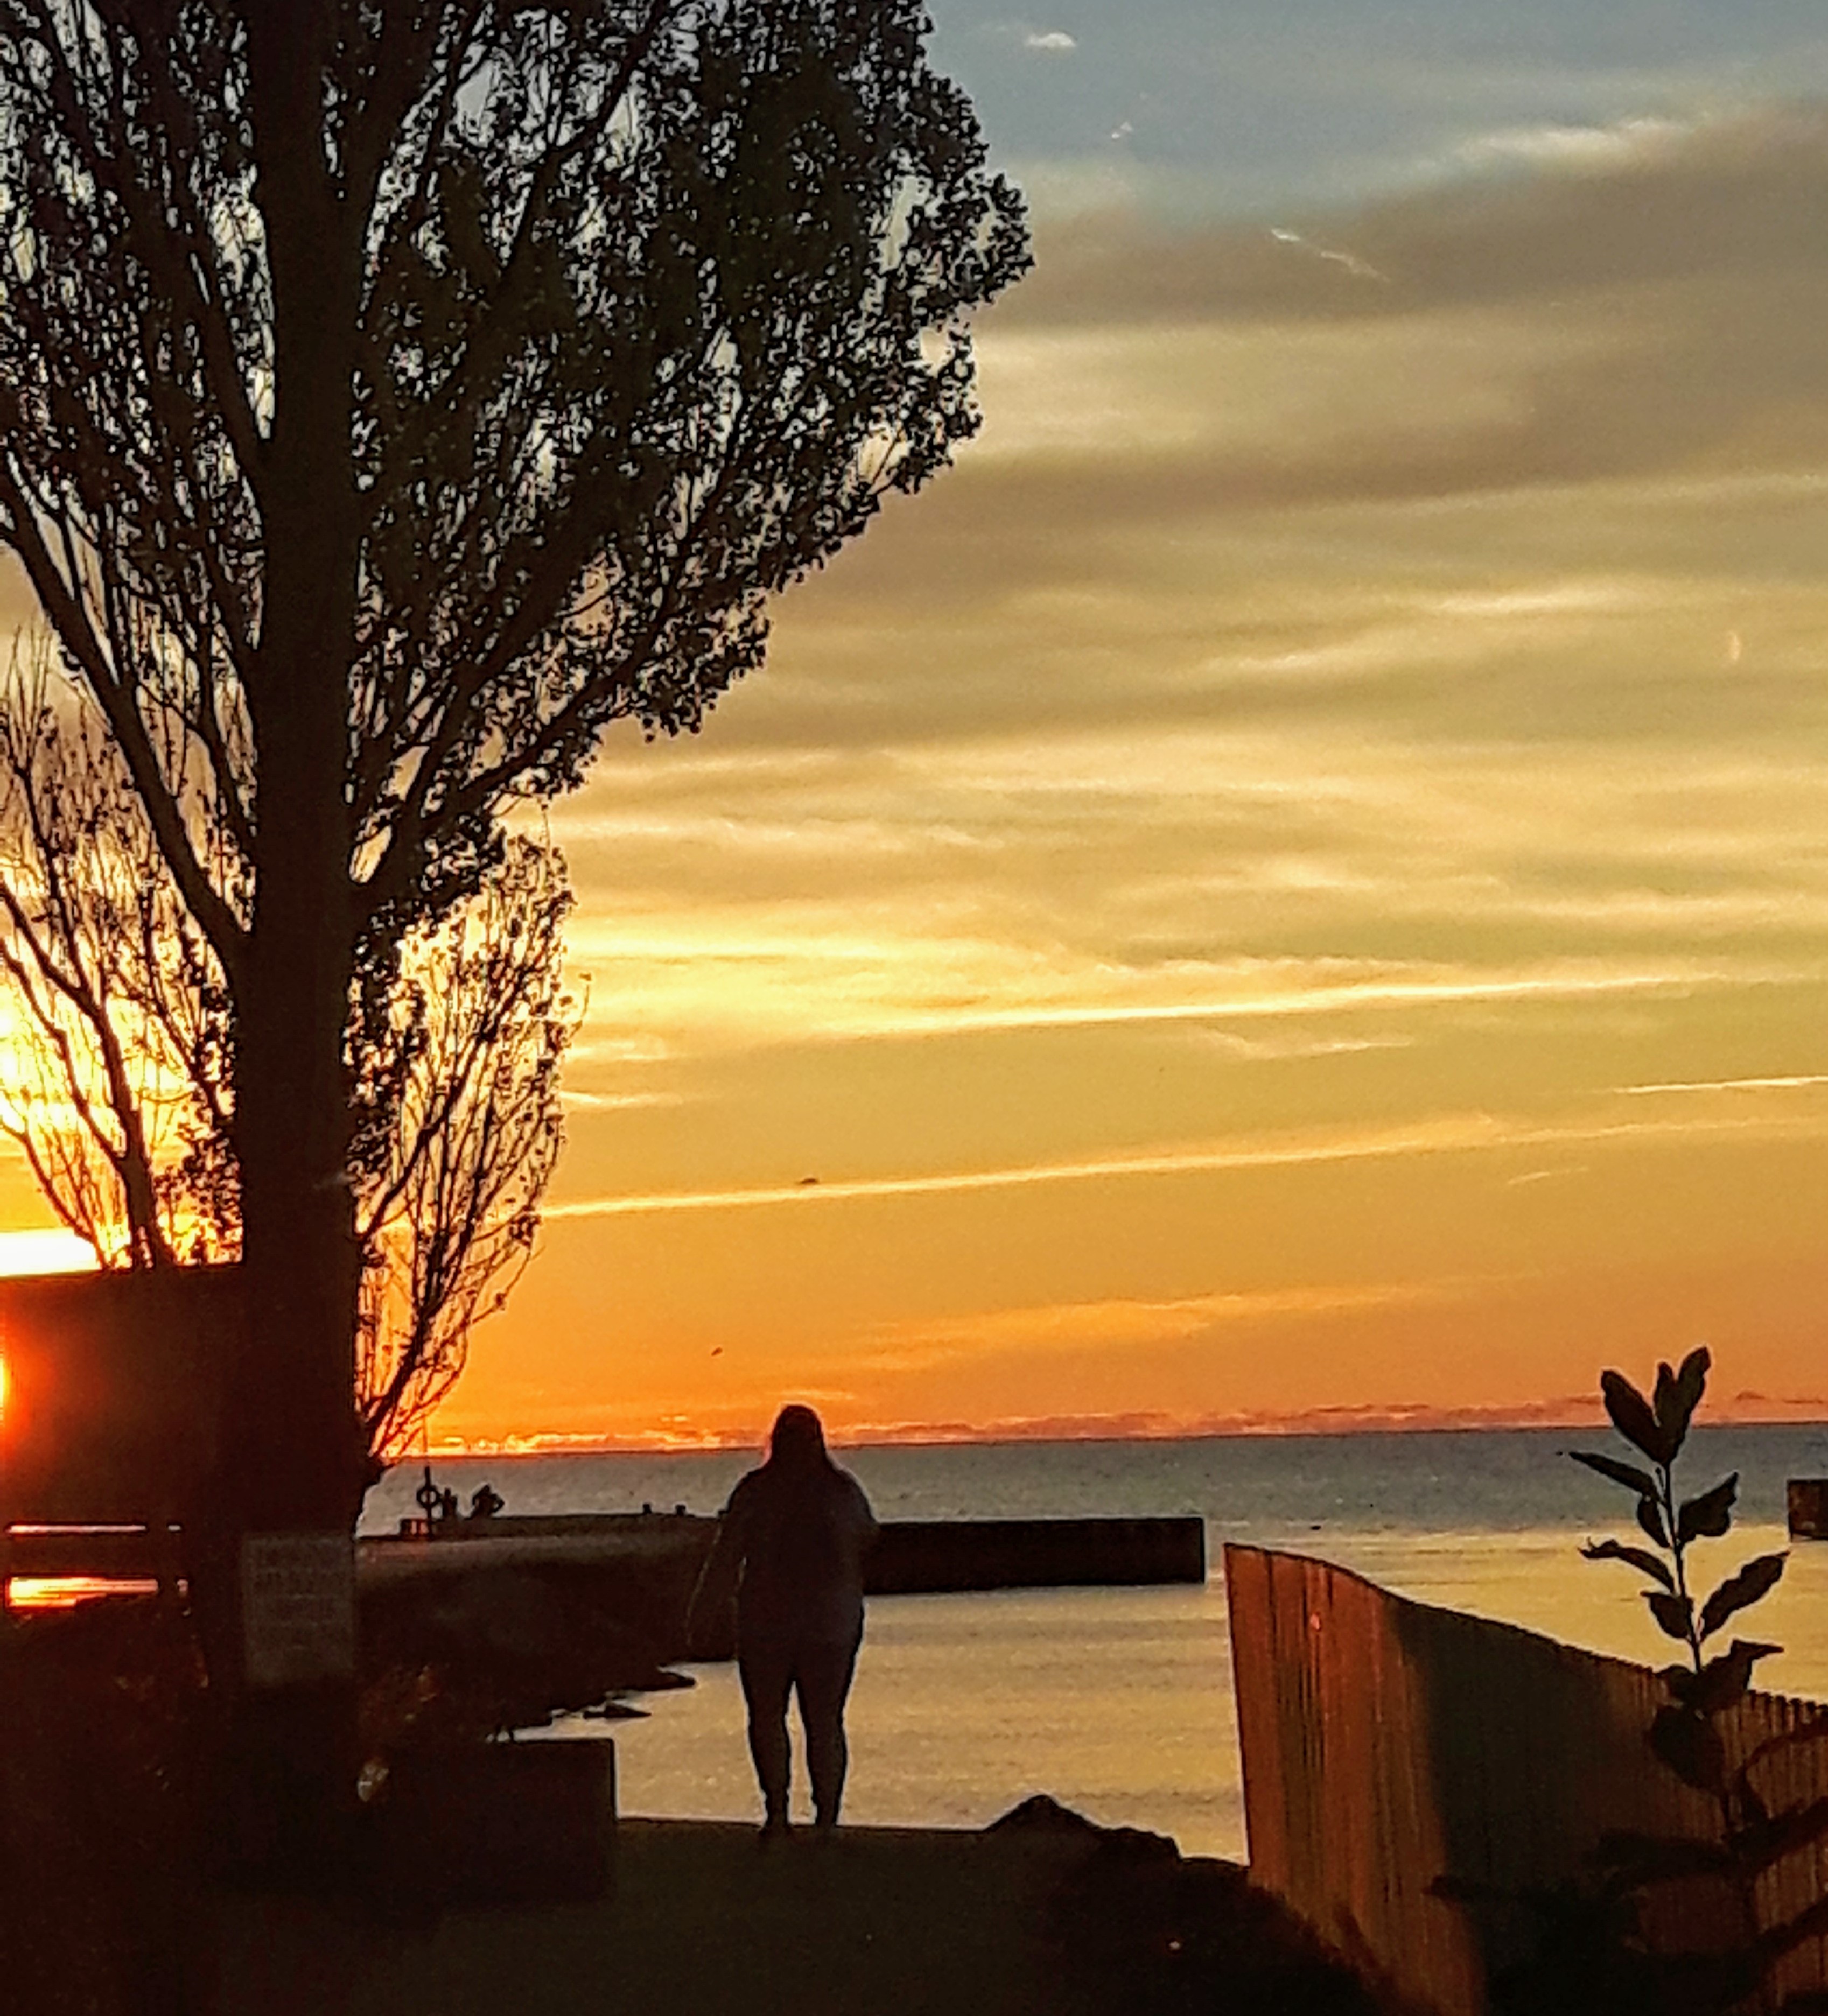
<box><xmin>206</xmin><ymin>0</ymin><xmax>367</xmax><ymax>1879</ymax></box>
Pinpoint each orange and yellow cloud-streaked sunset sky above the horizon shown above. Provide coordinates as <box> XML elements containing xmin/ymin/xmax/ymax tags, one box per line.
<box><xmin>18</xmin><ymin>0</ymin><xmax>1828</xmax><ymax>1442</ymax></box>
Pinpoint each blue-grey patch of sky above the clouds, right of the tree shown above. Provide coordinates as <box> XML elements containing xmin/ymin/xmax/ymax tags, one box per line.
<box><xmin>931</xmin><ymin>0</ymin><xmax>1828</xmax><ymax>212</ymax></box>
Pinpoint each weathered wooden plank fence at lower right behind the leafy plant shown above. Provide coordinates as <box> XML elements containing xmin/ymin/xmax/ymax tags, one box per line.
<box><xmin>1225</xmin><ymin>1546</ymin><xmax>1828</xmax><ymax>2016</ymax></box>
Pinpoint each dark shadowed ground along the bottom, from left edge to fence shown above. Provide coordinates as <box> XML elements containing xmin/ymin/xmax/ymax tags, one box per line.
<box><xmin>0</xmin><ymin>1607</ymin><xmax>1377</xmax><ymax>2016</ymax></box>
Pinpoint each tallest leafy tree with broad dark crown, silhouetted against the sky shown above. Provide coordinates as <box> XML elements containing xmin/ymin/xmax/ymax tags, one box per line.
<box><xmin>0</xmin><ymin>0</ymin><xmax>1026</xmax><ymax>1572</ymax></box>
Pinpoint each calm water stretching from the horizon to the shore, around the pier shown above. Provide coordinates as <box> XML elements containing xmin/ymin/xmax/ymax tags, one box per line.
<box><xmin>365</xmin><ymin>1425</ymin><xmax>1828</xmax><ymax>1857</ymax></box>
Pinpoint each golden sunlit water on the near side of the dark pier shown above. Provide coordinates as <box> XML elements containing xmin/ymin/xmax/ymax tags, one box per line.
<box><xmin>580</xmin><ymin>1526</ymin><xmax>1828</xmax><ymax>1857</ymax></box>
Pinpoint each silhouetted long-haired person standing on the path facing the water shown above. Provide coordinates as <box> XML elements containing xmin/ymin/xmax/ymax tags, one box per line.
<box><xmin>691</xmin><ymin>1407</ymin><xmax>877</xmax><ymax>1835</ymax></box>
